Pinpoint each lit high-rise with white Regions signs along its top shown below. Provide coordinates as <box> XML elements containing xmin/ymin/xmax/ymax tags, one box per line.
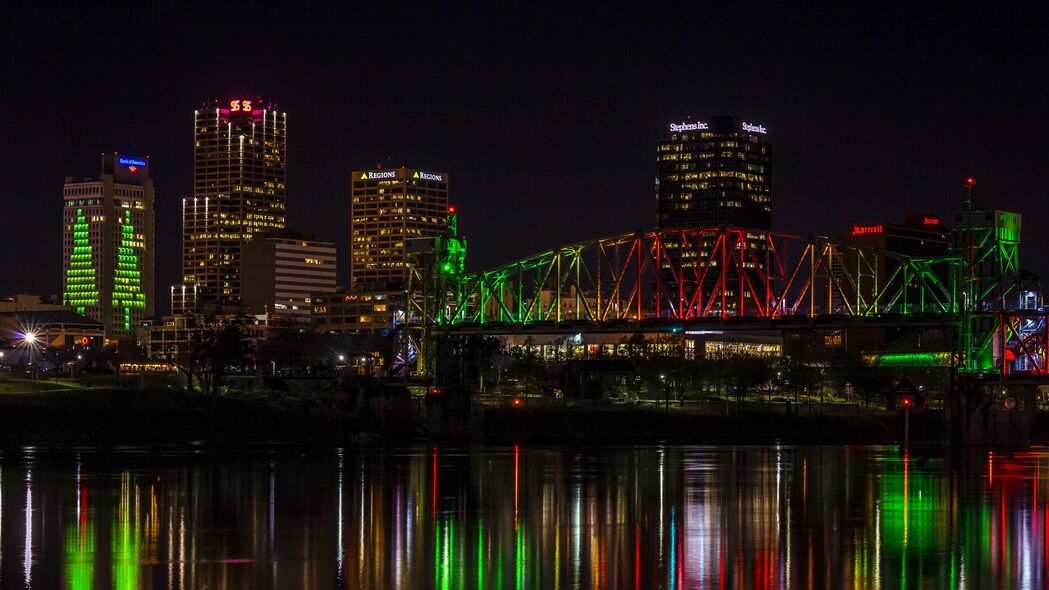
<box><xmin>349</xmin><ymin>166</ymin><xmax>448</xmax><ymax>291</ymax></box>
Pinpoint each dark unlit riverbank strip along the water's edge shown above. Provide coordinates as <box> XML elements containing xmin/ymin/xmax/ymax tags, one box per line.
<box><xmin>0</xmin><ymin>387</ymin><xmax>1044</xmax><ymax>446</ymax></box>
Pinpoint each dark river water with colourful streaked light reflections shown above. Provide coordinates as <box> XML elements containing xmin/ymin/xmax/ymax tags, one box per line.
<box><xmin>0</xmin><ymin>446</ymin><xmax>1049</xmax><ymax>589</ymax></box>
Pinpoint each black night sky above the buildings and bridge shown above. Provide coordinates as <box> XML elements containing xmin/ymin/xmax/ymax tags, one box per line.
<box><xmin>0</xmin><ymin>2</ymin><xmax>1049</xmax><ymax>311</ymax></box>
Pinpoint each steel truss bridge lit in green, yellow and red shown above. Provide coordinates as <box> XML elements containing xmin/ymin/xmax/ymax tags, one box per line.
<box><xmin>409</xmin><ymin>222</ymin><xmax>1049</xmax><ymax>375</ymax></box>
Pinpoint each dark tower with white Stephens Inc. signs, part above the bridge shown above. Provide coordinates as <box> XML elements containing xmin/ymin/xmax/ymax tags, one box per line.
<box><xmin>656</xmin><ymin>117</ymin><xmax>772</xmax><ymax>230</ymax></box>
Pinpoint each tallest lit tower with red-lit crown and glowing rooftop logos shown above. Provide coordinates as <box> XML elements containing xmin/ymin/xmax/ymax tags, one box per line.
<box><xmin>180</xmin><ymin>98</ymin><xmax>287</xmax><ymax>307</ymax></box>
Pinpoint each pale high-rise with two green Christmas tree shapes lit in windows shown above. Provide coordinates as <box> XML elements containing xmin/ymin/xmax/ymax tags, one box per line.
<box><xmin>62</xmin><ymin>153</ymin><xmax>154</xmax><ymax>339</ymax></box>
